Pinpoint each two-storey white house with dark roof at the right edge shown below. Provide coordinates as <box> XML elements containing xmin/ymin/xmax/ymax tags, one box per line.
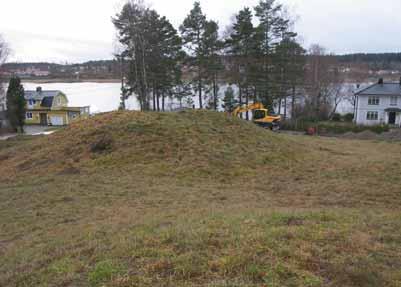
<box><xmin>355</xmin><ymin>79</ymin><xmax>401</xmax><ymax>127</ymax></box>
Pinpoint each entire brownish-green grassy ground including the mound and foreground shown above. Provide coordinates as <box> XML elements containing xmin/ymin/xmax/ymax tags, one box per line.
<box><xmin>0</xmin><ymin>112</ymin><xmax>401</xmax><ymax>286</ymax></box>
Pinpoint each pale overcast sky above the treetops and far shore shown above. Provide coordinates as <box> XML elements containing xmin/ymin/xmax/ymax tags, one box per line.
<box><xmin>0</xmin><ymin>0</ymin><xmax>401</xmax><ymax>63</ymax></box>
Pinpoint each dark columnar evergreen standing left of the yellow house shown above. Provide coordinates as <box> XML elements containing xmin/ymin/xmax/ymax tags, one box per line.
<box><xmin>7</xmin><ymin>77</ymin><xmax>26</xmax><ymax>133</ymax></box>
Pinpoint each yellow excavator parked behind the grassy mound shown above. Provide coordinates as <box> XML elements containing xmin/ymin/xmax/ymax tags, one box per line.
<box><xmin>232</xmin><ymin>103</ymin><xmax>281</xmax><ymax>130</ymax></box>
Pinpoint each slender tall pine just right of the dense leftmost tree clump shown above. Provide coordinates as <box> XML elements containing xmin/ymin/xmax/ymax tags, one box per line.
<box><xmin>180</xmin><ymin>1</ymin><xmax>207</xmax><ymax>109</ymax></box>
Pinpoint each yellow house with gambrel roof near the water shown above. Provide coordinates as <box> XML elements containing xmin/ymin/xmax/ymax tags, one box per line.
<box><xmin>25</xmin><ymin>87</ymin><xmax>90</xmax><ymax>126</ymax></box>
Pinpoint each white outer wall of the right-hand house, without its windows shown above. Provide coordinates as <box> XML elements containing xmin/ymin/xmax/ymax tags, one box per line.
<box><xmin>356</xmin><ymin>95</ymin><xmax>401</xmax><ymax>125</ymax></box>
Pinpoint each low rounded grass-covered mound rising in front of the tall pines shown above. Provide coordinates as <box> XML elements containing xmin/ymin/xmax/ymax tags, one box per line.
<box><xmin>0</xmin><ymin>111</ymin><xmax>301</xmax><ymax>181</ymax></box>
